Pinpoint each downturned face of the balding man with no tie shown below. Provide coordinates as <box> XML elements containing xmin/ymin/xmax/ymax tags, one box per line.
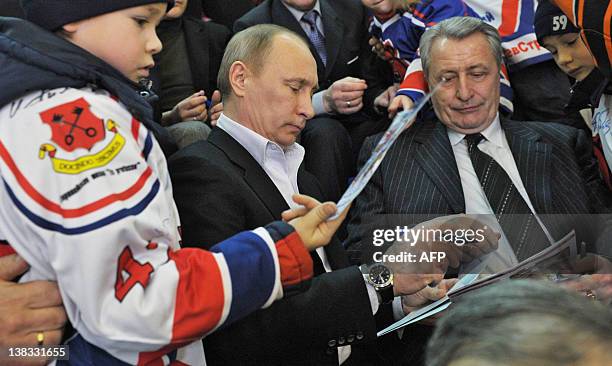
<box><xmin>241</xmin><ymin>35</ymin><xmax>317</xmax><ymax>147</ymax></box>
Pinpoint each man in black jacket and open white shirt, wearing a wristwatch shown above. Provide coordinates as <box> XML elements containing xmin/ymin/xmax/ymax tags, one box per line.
<box><xmin>169</xmin><ymin>25</ymin><xmax>494</xmax><ymax>365</ymax></box>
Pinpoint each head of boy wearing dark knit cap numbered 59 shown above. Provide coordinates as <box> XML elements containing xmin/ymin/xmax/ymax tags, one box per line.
<box><xmin>534</xmin><ymin>1</ymin><xmax>595</xmax><ymax>81</ymax></box>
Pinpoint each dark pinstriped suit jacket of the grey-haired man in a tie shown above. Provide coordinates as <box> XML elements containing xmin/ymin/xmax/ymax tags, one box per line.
<box><xmin>345</xmin><ymin>119</ymin><xmax>610</xmax><ymax>261</ymax></box>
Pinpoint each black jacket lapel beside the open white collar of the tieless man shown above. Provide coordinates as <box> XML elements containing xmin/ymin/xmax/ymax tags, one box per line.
<box><xmin>208</xmin><ymin>128</ymin><xmax>289</xmax><ymax>220</ymax></box>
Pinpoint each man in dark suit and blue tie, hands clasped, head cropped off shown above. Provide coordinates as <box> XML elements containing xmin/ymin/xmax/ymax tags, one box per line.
<box><xmin>234</xmin><ymin>0</ymin><xmax>389</xmax><ymax>201</ymax></box>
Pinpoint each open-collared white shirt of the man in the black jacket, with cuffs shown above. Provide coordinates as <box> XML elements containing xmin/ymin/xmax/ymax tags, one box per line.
<box><xmin>217</xmin><ymin>113</ymin><xmax>354</xmax><ymax>364</ymax></box>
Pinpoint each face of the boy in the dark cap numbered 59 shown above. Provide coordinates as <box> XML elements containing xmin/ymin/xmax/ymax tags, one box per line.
<box><xmin>542</xmin><ymin>33</ymin><xmax>595</xmax><ymax>81</ymax></box>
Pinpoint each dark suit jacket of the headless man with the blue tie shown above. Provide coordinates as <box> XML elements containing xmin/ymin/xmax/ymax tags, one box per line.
<box><xmin>234</xmin><ymin>0</ymin><xmax>390</xmax><ymax>117</ymax></box>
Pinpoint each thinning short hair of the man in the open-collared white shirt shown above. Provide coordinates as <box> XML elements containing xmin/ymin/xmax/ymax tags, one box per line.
<box><xmin>217</xmin><ymin>24</ymin><xmax>308</xmax><ymax>99</ymax></box>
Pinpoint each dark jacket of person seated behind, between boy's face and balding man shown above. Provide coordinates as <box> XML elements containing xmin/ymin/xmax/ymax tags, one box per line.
<box><xmin>150</xmin><ymin>16</ymin><xmax>232</xmax><ymax>121</ymax></box>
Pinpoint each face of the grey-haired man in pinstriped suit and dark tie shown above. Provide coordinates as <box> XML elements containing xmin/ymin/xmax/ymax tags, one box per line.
<box><xmin>427</xmin><ymin>33</ymin><xmax>499</xmax><ymax>134</ymax></box>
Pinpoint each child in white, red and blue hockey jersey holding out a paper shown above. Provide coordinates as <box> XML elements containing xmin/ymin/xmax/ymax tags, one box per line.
<box><xmin>0</xmin><ymin>0</ymin><xmax>341</xmax><ymax>365</ymax></box>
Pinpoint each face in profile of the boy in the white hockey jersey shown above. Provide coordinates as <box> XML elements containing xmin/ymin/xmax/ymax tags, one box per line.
<box><xmin>64</xmin><ymin>3</ymin><xmax>167</xmax><ymax>82</ymax></box>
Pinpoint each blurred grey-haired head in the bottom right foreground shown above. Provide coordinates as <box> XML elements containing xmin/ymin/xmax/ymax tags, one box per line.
<box><xmin>426</xmin><ymin>280</ymin><xmax>612</xmax><ymax>366</ymax></box>
